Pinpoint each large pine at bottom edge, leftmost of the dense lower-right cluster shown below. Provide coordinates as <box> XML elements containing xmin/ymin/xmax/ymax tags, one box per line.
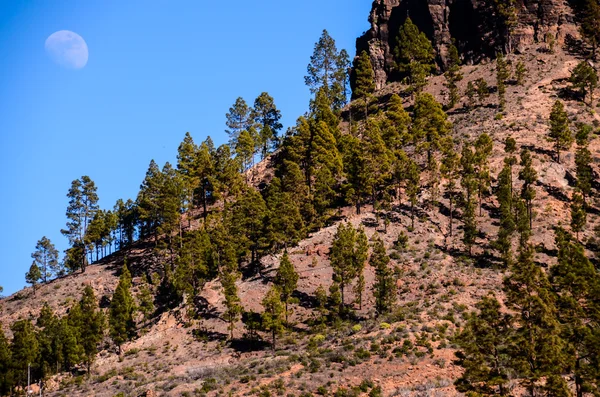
<box><xmin>454</xmin><ymin>295</ymin><xmax>511</xmax><ymax>396</ymax></box>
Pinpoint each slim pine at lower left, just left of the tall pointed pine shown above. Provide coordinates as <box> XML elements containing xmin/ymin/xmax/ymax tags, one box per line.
<box><xmin>79</xmin><ymin>285</ymin><xmax>104</xmax><ymax>376</ymax></box>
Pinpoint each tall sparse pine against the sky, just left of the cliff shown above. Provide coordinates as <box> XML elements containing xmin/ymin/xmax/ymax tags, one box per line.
<box><xmin>304</xmin><ymin>30</ymin><xmax>349</xmax><ymax>111</ymax></box>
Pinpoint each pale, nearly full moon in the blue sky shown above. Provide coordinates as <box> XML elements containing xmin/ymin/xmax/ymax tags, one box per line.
<box><xmin>45</xmin><ymin>30</ymin><xmax>88</xmax><ymax>69</ymax></box>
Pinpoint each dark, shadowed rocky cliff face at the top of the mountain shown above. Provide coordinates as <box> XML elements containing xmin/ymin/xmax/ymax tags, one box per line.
<box><xmin>356</xmin><ymin>0</ymin><xmax>577</xmax><ymax>88</ymax></box>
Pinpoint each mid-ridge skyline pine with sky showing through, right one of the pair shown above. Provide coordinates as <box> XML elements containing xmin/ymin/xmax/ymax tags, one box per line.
<box><xmin>252</xmin><ymin>92</ymin><xmax>283</xmax><ymax>159</ymax></box>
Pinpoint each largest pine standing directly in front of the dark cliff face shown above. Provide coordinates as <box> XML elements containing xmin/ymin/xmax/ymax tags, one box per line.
<box><xmin>393</xmin><ymin>17</ymin><xmax>435</xmax><ymax>92</ymax></box>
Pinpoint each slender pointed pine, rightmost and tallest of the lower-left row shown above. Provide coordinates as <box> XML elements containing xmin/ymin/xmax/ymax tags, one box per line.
<box><xmin>108</xmin><ymin>263</ymin><xmax>135</xmax><ymax>354</ymax></box>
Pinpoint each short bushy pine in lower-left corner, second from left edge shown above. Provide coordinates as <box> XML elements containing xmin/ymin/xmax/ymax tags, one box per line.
<box><xmin>10</xmin><ymin>320</ymin><xmax>40</xmax><ymax>387</ymax></box>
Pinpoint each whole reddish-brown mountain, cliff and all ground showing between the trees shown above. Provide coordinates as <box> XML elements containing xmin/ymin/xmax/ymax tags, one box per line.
<box><xmin>0</xmin><ymin>0</ymin><xmax>600</xmax><ymax>397</ymax></box>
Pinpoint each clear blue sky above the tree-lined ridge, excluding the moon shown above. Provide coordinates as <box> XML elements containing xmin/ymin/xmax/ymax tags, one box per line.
<box><xmin>0</xmin><ymin>0</ymin><xmax>371</xmax><ymax>295</ymax></box>
